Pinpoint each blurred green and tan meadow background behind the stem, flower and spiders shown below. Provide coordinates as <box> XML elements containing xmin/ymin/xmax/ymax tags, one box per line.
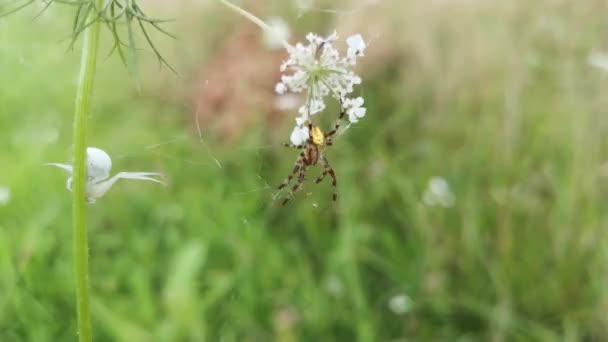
<box><xmin>0</xmin><ymin>0</ymin><xmax>608</xmax><ymax>341</ymax></box>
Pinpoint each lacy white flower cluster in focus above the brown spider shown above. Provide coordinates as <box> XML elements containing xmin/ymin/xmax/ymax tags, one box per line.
<box><xmin>275</xmin><ymin>32</ymin><xmax>366</xmax><ymax>140</ymax></box>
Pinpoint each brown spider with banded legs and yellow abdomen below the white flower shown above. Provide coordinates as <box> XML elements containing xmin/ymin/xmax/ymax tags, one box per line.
<box><xmin>279</xmin><ymin>109</ymin><xmax>346</xmax><ymax>205</ymax></box>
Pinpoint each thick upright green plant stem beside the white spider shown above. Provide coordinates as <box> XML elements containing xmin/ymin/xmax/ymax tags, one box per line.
<box><xmin>72</xmin><ymin>0</ymin><xmax>103</xmax><ymax>342</ymax></box>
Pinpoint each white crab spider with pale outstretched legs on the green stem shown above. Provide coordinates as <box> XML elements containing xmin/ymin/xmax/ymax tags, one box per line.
<box><xmin>44</xmin><ymin>147</ymin><xmax>165</xmax><ymax>204</ymax></box>
